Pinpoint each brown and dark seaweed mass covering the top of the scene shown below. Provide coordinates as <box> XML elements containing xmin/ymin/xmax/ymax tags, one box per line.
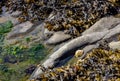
<box><xmin>2</xmin><ymin>0</ymin><xmax>120</xmax><ymax>36</ymax></box>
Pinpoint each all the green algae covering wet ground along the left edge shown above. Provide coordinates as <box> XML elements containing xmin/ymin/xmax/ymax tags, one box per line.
<box><xmin>0</xmin><ymin>21</ymin><xmax>47</xmax><ymax>81</ymax></box>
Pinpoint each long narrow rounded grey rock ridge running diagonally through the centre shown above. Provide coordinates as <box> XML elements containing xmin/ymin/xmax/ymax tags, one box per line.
<box><xmin>43</xmin><ymin>31</ymin><xmax>108</xmax><ymax>67</ymax></box>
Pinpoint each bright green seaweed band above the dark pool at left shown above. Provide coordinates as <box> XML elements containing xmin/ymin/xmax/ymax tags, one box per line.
<box><xmin>2</xmin><ymin>44</ymin><xmax>45</xmax><ymax>62</ymax></box>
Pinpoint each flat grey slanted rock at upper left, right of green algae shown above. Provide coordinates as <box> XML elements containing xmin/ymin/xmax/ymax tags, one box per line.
<box><xmin>7</xmin><ymin>21</ymin><xmax>35</xmax><ymax>39</ymax></box>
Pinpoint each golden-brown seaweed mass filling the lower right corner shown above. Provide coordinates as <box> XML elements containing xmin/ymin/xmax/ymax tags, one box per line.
<box><xmin>35</xmin><ymin>48</ymin><xmax>120</xmax><ymax>81</ymax></box>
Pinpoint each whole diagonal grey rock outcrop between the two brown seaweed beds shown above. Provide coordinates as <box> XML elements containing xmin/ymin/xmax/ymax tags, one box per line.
<box><xmin>31</xmin><ymin>17</ymin><xmax>120</xmax><ymax>78</ymax></box>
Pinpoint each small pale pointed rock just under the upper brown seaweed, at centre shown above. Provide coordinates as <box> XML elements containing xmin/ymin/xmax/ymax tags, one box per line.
<box><xmin>46</xmin><ymin>32</ymin><xmax>71</xmax><ymax>45</ymax></box>
